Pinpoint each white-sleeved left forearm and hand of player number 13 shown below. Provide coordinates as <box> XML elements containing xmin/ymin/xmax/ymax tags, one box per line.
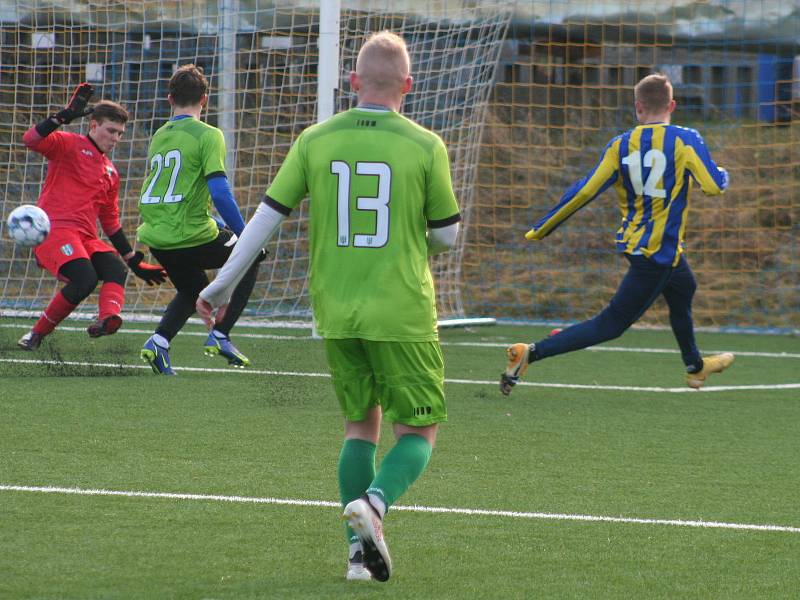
<box><xmin>197</xmin><ymin>202</ymin><xmax>286</xmax><ymax>326</ymax></box>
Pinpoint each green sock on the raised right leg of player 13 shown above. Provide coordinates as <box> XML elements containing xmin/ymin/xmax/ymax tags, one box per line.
<box><xmin>367</xmin><ymin>433</ymin><xmax>433</xmax><ymax>508</ymax></box>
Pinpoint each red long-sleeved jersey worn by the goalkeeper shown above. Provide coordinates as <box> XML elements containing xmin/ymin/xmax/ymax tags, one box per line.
<box><xmin>23</xmin><ymin>127</ymin><xmax>120</xmax><ymax>237</ymax></box>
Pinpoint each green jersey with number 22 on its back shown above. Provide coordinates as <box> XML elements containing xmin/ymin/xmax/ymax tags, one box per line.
<box><xmin>137</xmin><ymin>117</ymin><xmax>225</xmax><ymax>250</ymax></box>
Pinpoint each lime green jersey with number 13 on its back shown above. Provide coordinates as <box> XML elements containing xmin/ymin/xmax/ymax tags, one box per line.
<box><xmin>267</xmin><ymin>108</ymin><xmax>460</xmax><ymax>342</ymax></box>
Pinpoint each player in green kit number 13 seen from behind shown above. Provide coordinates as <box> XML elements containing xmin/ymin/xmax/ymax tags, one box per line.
<box><xmin>197</xmin><ymin>32</ymin><xmax>461</xmax><ymax>581</ymax></box>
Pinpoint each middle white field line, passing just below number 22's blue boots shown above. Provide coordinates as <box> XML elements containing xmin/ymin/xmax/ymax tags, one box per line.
<box><xmin>0</xmin><ymin>358</ymin><xmax>800</xmax><ymax>394</ymax></box>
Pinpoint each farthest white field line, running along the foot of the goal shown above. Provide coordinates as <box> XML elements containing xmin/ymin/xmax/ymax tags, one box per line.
<box><xmin>0</xmin><ymin>323</ymin><xmax>800</xmax><ymax>358</ymax></box>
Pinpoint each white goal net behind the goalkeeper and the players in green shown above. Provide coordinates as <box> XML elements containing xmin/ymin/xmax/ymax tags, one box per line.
<box><xmin>0</xmin><ymin>0</ymin><xmax>511</xmax><ymax>320</ymax></box>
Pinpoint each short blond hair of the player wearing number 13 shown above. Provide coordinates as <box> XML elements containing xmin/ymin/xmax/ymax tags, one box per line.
<box><xmin>356</xmin><ymin>31</ymin><xmax>411</xmax><ymax>91</ymax></box>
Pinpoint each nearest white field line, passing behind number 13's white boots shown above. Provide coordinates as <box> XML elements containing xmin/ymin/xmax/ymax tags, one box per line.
<box><xmin>0</xmin><ymin>484</ymin><xmax>800</xmax><ymax>533</ymax></box>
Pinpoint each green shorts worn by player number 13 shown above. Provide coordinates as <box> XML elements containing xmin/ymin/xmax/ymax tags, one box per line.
<box><xmin>325</xmin><ymin>338</ymin><xmax>447</xmax><ymax>427</ymax></box>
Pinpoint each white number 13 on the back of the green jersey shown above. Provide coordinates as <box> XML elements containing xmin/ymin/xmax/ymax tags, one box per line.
<box><xmin>331</xmin><ymin>160</ymin><xmax>392</xmax><ymax>248</ymax></box>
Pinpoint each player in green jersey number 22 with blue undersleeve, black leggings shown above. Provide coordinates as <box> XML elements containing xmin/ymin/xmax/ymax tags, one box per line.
<box><xmin>138</xmin><ymin>65</ymin><xmax>258</xmax><ymax>375</ymax></box>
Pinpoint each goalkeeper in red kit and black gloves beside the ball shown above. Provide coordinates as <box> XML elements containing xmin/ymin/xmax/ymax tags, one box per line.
<box><xmin>18</xmin><ymin>83</ymin><xmax>166</xmax><ymax>350</ymax></box>
